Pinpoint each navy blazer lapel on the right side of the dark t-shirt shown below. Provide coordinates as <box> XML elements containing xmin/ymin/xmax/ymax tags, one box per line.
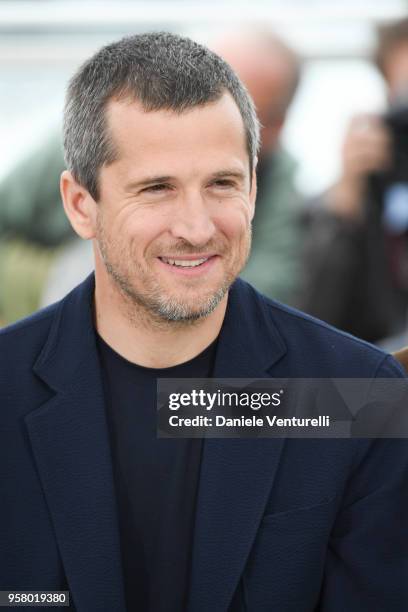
<box><xmin>188</xmin><ymin>281</ymin><xmax>286</xmax><ymax>612</ymax></box>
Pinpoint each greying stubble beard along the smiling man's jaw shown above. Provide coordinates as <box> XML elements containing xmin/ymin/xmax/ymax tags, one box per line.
<box><xmin>96</xmin><ymin>215</ymin><xmax>251</xmax><ymax>325</ymax></box>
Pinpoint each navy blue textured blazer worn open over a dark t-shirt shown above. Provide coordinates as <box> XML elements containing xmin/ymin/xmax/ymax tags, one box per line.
<box><xmin>0</xmin><ymin>276</ymin><xmax>408</xmax><ymax>612</ymax></box>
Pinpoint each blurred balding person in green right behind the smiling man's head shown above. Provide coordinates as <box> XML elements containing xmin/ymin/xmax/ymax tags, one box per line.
<box><xmin>211</xmin><ymin>26</ymin><xmax>302</xmax><ymax>304</ymax></box>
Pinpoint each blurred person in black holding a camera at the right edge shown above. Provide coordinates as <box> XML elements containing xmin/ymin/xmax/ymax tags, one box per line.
<box><xmin>297</xmin><ymin>19</ymin><xmax>408</xmax><ymax>342</ymax></box>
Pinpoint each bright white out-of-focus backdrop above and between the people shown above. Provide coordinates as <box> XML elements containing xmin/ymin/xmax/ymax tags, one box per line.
<box><xmin>0</xmin><ymin>0</ymin><xmax>408</xmax><ymax>194</ymax></box>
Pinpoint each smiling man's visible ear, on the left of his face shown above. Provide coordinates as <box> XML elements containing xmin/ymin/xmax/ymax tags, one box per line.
<box><xmin>60</xmin><ymin>170</ymin><xmax>97</xmax><ymax>240</ymax></box>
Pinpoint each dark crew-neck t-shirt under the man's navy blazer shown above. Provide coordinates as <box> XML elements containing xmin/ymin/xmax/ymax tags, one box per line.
<box><xmin>98</xmin><ymin>337</ymin><xmax>216</xmax><ymax>612</ymax></box>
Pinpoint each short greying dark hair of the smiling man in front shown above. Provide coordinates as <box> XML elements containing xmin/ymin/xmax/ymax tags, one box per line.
<box><xmin>64</xmin><ymin>32</ymin><xmax>259</xmax><ymax>200</ymax></box>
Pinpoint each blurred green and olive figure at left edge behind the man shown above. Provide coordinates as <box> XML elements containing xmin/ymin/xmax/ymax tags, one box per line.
<box><xmin>0</xmin><ymin>130</ymin><xmax>74</xmax><ymax>324</ymax></box>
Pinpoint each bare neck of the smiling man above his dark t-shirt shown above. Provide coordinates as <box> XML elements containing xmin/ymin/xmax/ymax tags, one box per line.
<box><xmin>95</xmin><ymin>275</ymin><xmax>228</xmax><ymax>368</ymax></box>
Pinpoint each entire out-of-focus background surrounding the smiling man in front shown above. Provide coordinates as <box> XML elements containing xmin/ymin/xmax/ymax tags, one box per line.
<box><xmin>0</xmin><ymin>0</ymin><xmax>408</xmax><ymax>346</ymax></box>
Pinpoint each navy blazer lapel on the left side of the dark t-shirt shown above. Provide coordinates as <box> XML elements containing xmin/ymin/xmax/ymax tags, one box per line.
<box><xmin>25</xmin><ymin>277</ymin><xmax>126</xmax><ymax>612</ymax></box>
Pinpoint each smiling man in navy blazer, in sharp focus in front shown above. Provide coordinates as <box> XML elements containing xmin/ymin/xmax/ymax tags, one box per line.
<box><xmin>0</xmin><ymin>33</ymin><xmax>408</xmax><ymax>612</ymax></box>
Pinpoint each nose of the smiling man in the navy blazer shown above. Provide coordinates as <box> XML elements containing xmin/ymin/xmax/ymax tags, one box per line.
<box><xmin>170</xmin><ymin>193</ymin><xmax>216</xmax><ymax>247</ymax></box>
